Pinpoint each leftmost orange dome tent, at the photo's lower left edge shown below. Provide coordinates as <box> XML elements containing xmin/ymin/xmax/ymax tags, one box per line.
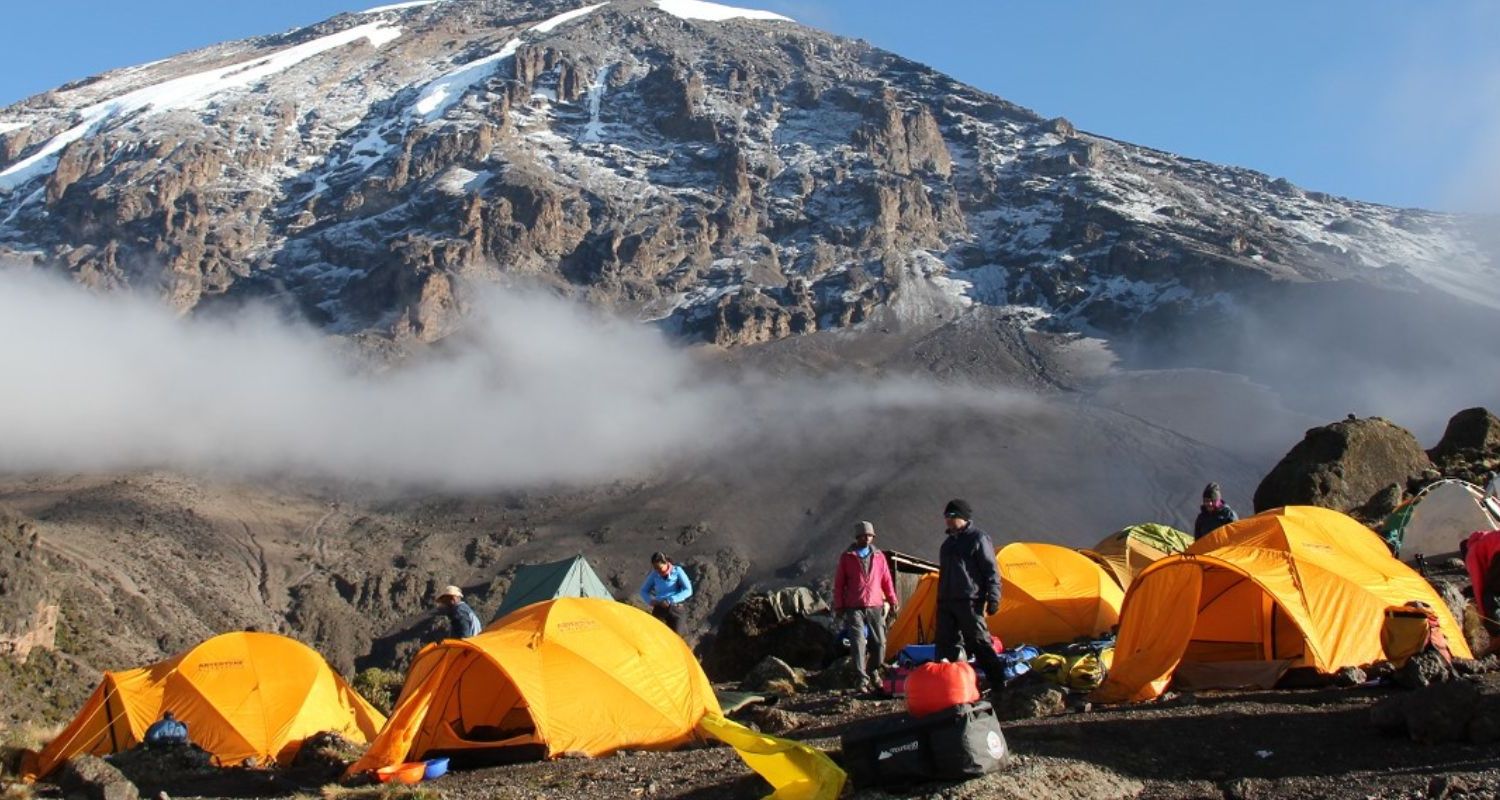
<box><xmin>23</xmin><ymin>633</ymin><xmax>386</xmax><ymax>780</ymax></box>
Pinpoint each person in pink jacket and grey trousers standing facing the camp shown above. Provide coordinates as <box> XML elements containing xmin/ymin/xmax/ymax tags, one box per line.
<box><xmin>834</xmin><ymin>522</ymin><xmax>900</xmax><ymax>689</ymax></box>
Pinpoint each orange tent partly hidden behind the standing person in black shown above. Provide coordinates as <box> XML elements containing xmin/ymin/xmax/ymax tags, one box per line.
<box><xmin>887</xmin><ymin>542</ymin><xmax>1125</xmax><ymax>656</ymax></box>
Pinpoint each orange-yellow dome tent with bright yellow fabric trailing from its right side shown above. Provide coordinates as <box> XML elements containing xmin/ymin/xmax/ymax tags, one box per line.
<box><xmin>348</xmin><ymin>597</ymin><xmax>845</xmax><ymax>800</ymax></box>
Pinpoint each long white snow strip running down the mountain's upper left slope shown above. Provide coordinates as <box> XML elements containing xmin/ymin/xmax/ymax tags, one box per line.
<box><xmin>0</xmin><ymin>23</ymin><xmax>401</xmax><ymax>192</ymax></box>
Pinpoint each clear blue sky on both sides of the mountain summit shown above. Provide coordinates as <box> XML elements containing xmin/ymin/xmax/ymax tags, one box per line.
<box><xmin>0</xmin><ymin>0</ymin><xmax>1500</xmax><ymax>212</ymax></box>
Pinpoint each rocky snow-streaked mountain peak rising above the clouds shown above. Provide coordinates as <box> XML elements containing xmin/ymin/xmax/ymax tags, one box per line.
<box><xmin>0</xmin><ymin>0</ymin><xmax>1500</xmax><ymax>344</ymax></box>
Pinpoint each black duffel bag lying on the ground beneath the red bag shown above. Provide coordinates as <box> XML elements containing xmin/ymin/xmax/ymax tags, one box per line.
<box><xmin>842</xmin><ymin>702</ymin><xmax>1011</xmax><ymax>786</ymax></box>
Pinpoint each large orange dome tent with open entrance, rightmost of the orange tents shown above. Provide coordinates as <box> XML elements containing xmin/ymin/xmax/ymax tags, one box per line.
<box><xmin>1095</xmin><ymin>506</ymin><xmax>1470</xmax><ymax>702</ymax></box>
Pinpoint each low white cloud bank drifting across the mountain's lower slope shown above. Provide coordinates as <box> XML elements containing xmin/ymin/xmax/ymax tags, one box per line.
<box><xmin>0</xmin><ymin>270</ymin><xmax>1026</xmax><ymax>489</ymax></box>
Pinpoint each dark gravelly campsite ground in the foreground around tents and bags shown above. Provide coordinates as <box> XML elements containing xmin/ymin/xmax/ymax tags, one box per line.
<box><xmin>17</xmin><ymin>674</ymin><xmax>1500</xmax><ymax>800</ymax></box>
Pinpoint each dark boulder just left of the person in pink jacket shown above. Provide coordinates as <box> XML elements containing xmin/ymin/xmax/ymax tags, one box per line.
<box><xmin>702</xmin><ymin>588</ymin><xmax>842</xmax><ymax>680</ymax></box>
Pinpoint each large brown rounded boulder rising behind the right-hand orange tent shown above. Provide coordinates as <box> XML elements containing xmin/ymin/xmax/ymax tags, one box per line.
<box><xmin>1256</xmin><ymin>417</ymin><xmax>1433</xmax><ymax>512</ymax></box>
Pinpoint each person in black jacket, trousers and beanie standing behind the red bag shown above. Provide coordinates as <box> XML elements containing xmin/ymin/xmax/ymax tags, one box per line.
<box><xmin>936</xmin><ymin>500</ymin><xmax>1005</xmax><ymax>698</ymax></box>
